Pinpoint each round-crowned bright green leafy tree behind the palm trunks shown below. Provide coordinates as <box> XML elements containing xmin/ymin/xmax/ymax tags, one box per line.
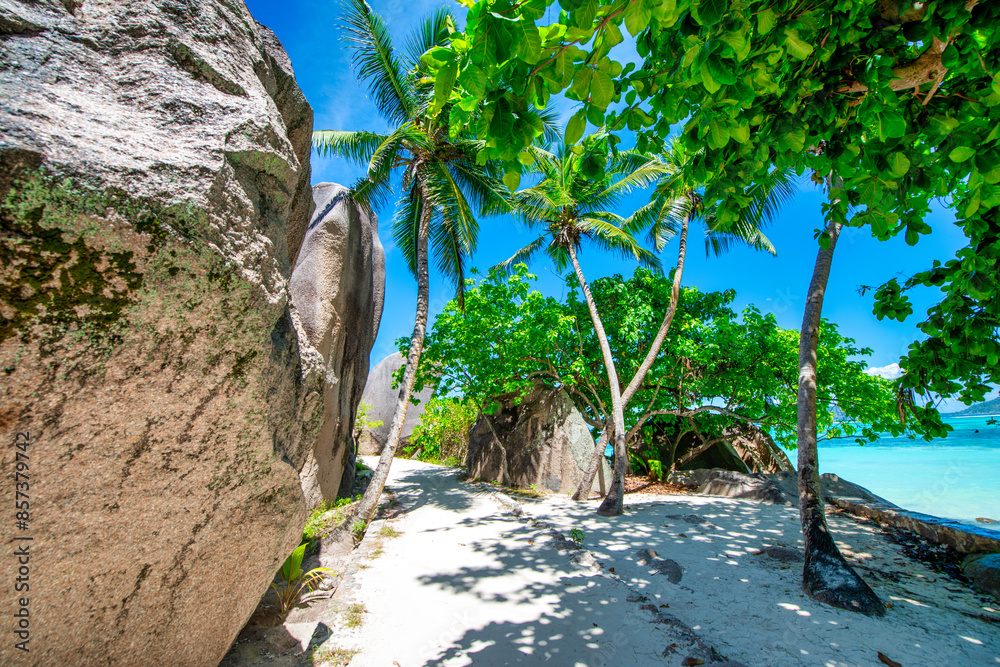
<box><xmin>408</xmin><ymin>265</ymin><xmax>947</xmax><ymax>449</ymax></box>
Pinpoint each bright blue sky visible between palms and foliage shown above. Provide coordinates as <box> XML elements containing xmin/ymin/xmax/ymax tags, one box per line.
<box><xmin>247</xmin><ymin>0</ymin><xmax>965</xmax><ymax>396</ymax></box>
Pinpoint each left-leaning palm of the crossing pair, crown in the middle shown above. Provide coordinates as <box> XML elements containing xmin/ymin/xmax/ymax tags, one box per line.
<box><xmin>500</xmin><ymin>131</ymin><xmax>666</xmax><ymax>514</ymax></box>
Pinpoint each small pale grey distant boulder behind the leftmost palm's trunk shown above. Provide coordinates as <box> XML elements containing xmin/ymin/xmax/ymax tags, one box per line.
<box><xmin>358</xmin><ymin>352</ymin><xmax>434</xmax><ymax>456</ymax></box>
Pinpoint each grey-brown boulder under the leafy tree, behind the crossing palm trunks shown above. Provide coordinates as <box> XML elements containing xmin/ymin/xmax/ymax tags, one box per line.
<box><xmin>467</xmin><ymin>386</ymin><xmax>611</xmax><ymax>493</ymax></box>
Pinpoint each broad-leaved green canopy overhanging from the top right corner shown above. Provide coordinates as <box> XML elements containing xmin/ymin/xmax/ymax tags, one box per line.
<box><xmin>423</xmin><ymin>0</ymin><xmax>1000</xmax><ymax>408</ymax></box>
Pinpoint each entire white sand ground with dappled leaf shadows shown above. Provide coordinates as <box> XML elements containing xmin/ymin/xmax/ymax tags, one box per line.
<box><xmin>310</xmin><ymin>460</ymin><xmax>1000</xmax><ymax>667</ymax></box>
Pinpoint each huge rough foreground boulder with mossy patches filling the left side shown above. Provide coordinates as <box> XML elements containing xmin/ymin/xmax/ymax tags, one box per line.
<box><xmin>0</xmin><ymin>0</ymin><xmax>318</xmax><ymax>665</ymax></box>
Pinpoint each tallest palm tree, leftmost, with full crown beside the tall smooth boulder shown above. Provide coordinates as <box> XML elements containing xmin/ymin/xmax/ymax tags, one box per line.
<box><xmin>313</xmin><ymin>0</ymin><xmax>547</xmax><ymax>541</ymax></box>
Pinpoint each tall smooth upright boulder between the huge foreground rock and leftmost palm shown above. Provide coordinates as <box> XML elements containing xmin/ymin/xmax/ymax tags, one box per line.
<box><xmin>288</xmin><ymin>183</ymin><xmax>385</xmax><ymax>509</ymax></box>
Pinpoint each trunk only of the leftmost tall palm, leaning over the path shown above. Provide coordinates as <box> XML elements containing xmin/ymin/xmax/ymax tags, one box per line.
<box><xmin>349</xmin><ymin>177</ymin><xmax>432</xmax><ymax>528</ymax></box>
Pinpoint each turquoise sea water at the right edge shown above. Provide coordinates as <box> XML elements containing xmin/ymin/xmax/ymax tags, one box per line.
<box><xmin>812</xmin><ymin>415</ymin><xmax>1000</xmax><ymax>530</ymax></box>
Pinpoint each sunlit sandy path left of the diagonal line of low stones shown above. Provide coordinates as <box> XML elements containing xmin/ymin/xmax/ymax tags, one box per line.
<box><xmin>342</xmin><ymin>460</ymin><xmax>728</xmax><ymax>667</ymax></box>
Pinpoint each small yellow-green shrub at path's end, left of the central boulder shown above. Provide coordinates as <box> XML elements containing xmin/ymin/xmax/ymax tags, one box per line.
<box><xmin>403</xmin><ymin>397</ymin><xmax>479</xmax><ymax>466</ymax></box>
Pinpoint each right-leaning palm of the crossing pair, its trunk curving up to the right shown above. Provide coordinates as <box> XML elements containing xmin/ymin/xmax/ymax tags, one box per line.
<box><xmin>573</xmin><ymin>143</ymin><xmax>794</xmax><ymax>516</ymax></box>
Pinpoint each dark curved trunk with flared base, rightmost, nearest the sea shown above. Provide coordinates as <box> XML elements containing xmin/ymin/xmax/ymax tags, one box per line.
<box><xmin>797</xmin><ymin>215</ymin><xmax>885</xmax><ymax>616</ymax></box>
